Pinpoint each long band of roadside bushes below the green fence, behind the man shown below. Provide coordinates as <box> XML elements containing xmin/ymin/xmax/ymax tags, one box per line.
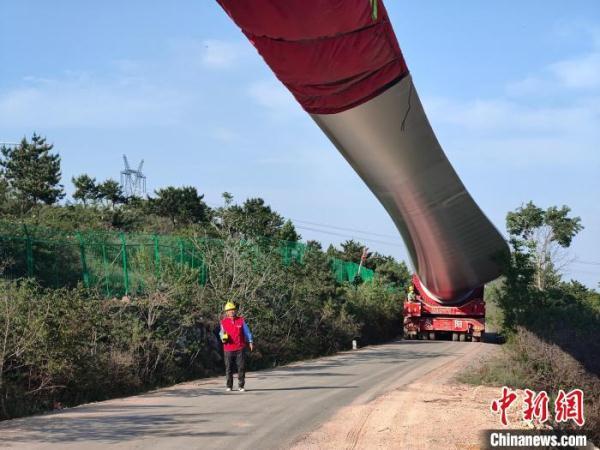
<box><xmin>0</xmin><ymin>239</ymin><xmax>402</xmax><ymax>419</ymax></box>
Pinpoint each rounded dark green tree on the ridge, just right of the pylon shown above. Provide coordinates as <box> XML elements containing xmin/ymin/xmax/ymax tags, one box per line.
<box><xmin>151</xmin><ymin>186</ymin><xmax>209</xmax><ymax>225</ymax></box>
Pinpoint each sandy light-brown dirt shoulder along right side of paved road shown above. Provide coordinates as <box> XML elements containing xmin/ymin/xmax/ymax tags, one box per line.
<box><xmin>293</xmin><ymin>343</ymin><xmax>516</xmax><ymax>450</ymax></box>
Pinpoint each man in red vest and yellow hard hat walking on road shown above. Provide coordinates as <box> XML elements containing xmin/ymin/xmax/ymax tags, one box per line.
<box><xmin>219</xmin><ymin>302</ymin><xmax>254</xmax><ymax>392</ymax></box>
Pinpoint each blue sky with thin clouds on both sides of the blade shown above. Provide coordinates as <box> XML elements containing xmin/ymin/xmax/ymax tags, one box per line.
<box><xmin>0</xmin><ymin>0</ymin><xmax>600</xmax><ymax>287</ymax></box>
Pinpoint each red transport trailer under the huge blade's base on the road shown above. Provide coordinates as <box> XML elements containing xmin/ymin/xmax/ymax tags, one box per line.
<box><xmin>404</xmin><ymin>274</ymin><xmax>485</xmax><ymax>342</ymax></box>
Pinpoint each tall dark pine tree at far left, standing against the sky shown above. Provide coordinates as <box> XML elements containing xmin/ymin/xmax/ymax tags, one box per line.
<box><xmin>0</xmin><ymin>133</ymin><xmax>65</xmax><ymax>210</ymax></box>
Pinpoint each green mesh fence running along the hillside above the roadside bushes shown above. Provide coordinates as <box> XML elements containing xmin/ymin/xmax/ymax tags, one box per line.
<box><xmin>0</xmin><ymin>222</ymin><xmax>374</xmax><ymax>297</ymax></box>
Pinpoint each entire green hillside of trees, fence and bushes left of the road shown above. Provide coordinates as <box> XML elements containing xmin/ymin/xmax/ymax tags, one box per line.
<box><xmin>0</xmin><ymin>135</ymin><xmax>409</xmax><ymax>419</ymax></box>
